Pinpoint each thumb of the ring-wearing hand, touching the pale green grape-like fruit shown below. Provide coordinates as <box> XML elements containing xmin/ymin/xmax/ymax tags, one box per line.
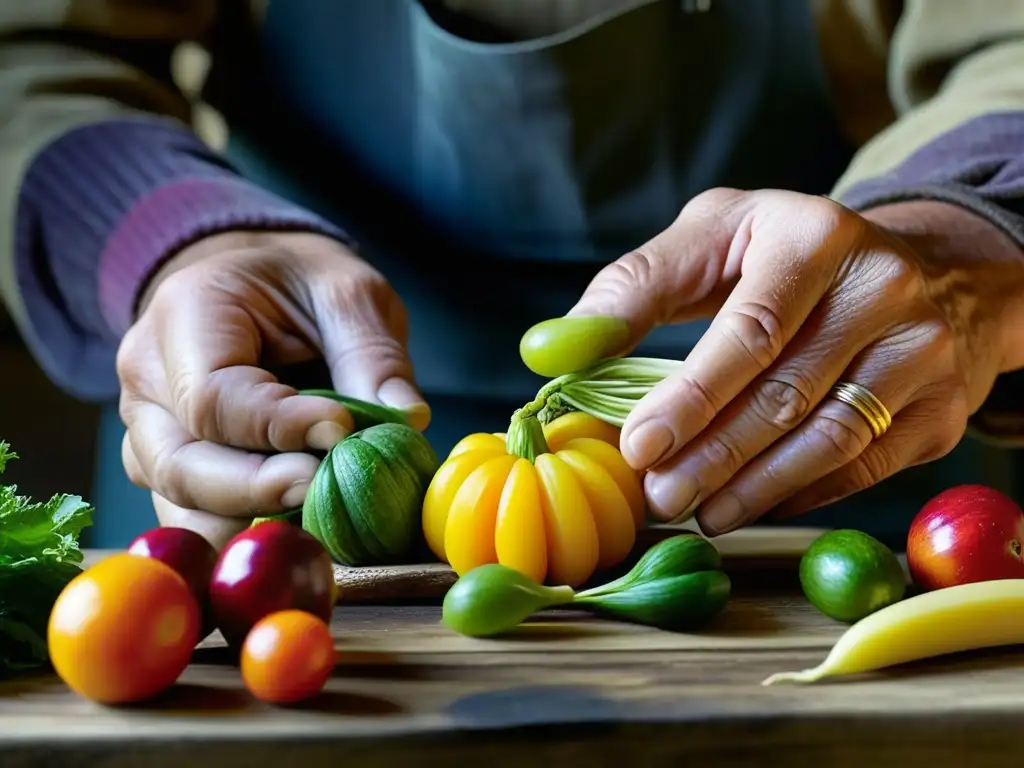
<box><xmin>566</xmin><ymin>189</ymin><xmax>752</xmax><ymax>354</ymax></box>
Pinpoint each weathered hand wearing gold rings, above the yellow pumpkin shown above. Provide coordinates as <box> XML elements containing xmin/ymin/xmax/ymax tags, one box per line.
<box><xmin>570</xmin><ymin>189</ymin><xmax>1024</xmax><ymax>535</ymax></box>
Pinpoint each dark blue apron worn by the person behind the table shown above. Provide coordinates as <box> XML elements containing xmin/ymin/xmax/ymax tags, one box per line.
<box><xmin>90</xmin><ymin>0</ymin><xmax>1006</xmax><ymax>546</ymax></box>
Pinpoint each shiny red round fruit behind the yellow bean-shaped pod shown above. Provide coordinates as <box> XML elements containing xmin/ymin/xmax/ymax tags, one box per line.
<box><xmin>906</xmin><ymin>485</ymin><xmax>1024</xmax><ymax>590</ymax></box>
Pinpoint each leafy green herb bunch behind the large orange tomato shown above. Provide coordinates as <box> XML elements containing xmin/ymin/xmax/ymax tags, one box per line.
<box><xmin>0</xmin><ymin>440</ymin><xmax>93</xmax><ymax>679</ymax></box>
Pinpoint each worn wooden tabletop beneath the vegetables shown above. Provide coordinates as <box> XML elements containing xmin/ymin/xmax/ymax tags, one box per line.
<box><xmin>0</xmin><ymin>536</ymin><xmax>1024</xmax><ymax>768</ymax></box>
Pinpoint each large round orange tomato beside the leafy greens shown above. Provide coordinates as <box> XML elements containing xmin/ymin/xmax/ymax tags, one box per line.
<box><xmin>47</xmin><ymin>553</ymin><xmax>202</xmax><ymax>705</ymax></box>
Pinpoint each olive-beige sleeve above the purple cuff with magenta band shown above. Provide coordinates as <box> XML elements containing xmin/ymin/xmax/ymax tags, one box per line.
<box><xmin>0</xmin><ymin>0</ymin><xmax>216</xmax><ymax>333</ymax></box>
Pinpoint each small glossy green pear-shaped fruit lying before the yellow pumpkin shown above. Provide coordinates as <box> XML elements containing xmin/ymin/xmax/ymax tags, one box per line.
<box><xmin>441</xmin><ymin>563</ymin><xmax>572</xmax><ymax>637</ymax></box>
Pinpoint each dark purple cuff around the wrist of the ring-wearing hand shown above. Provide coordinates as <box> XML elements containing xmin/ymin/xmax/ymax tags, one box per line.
<box><xmin>840</xmin><ymin>111</ymin><xmax>1024</xmax><ymax>444</ymax></box>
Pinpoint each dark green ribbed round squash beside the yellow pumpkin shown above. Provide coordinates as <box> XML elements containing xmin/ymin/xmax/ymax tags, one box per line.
<box><xmin>302</xmin><ymin>423</ymin><xmax>438</xmax><ymax>565</ymax></box>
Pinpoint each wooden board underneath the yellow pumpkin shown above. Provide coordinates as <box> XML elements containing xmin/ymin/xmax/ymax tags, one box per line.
<box><xmin>86</xmin><ymin>522</ymin><xmax>825</xmax><ymax>603</ymax></box>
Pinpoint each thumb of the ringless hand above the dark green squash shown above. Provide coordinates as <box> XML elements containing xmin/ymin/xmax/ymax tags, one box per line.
<box><xmin>313</xmin><ymin>265</ymin><xmax>430</xmax><ymax>431</ymax></box>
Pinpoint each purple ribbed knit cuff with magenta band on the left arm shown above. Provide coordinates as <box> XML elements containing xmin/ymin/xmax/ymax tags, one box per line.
<box><xmin>14</xmin><ymin>117</ymin><xmax>347</xmax><ymax>400</ymax></box>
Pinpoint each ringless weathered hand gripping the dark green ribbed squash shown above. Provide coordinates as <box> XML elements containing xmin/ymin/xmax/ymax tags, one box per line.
<box><xmin>118</xmin><ymin>232</ymin><xmax>429</xmax><ymax>546</ymax></box>
